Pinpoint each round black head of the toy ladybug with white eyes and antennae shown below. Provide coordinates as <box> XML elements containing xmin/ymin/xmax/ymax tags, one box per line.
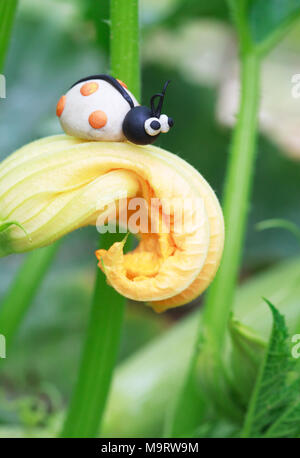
<box><xmin>123</xmin><ymin>81</ymin><xmax>174</xmax><ymax>145</ymax></box>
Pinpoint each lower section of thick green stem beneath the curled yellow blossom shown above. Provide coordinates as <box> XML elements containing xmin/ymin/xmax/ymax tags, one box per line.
<box><xmin>61</xmin><ymin>234</ymin><xmax>125</xmax><ymax>438</ymax></box>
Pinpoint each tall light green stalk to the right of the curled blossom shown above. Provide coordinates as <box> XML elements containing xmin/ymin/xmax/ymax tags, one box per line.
<box><xmin>168</xmin><ymin>50</ymin><xmax>259</xmax><ymax>437</ymax></box>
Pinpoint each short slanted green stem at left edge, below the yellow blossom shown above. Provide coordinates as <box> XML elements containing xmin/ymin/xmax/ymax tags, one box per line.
<box><xmin>0</xmin><ymin>244</ymin><xmax>58</xmax><ymax>348</ymax></box>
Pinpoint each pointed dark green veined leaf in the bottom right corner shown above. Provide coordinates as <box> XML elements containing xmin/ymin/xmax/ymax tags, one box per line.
<box><xmin>241</xmin><ymin>300</ymin><xmax>300</xmax><ymax>437</ymax></box>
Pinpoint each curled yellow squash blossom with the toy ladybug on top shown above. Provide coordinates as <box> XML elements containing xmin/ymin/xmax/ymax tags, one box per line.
<box><xmin>0</xmin><ymin>135</ymin><xmax>224</xmax><ymax>312</ymax></box>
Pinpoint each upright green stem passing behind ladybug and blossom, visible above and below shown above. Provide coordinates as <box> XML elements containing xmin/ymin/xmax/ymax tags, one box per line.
<box><xmin>61</xmin><ymin>0</ymin><xmax>140</xmax><ymax>437</ymax></box>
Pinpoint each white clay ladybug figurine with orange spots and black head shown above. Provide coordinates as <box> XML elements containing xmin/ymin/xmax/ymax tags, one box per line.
<box><xmin>56</xmin><ymin>75</ymin><xmax>174</xmax><ymax>145</ymax></box>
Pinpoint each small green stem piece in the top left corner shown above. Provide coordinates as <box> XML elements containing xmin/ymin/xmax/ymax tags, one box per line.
<box><xmin>0</xmin><ymin>0</ymin><xmax>18</xmax><ymax>72</ymax></box>
